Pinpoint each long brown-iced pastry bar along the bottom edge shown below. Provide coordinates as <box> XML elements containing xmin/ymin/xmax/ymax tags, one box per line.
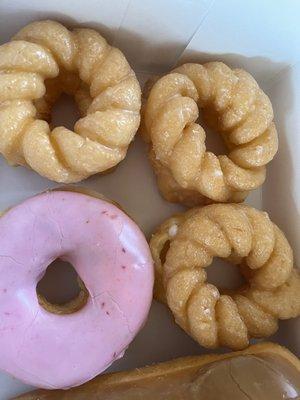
<box><xmin>13</xmin><ymin>343</ymin><xmax>300</xmax><ymax>400</ymax></box>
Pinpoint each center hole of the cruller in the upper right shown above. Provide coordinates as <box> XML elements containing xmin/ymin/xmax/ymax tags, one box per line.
<box><xmin>196</xmin><ymin>109</ymin><xmax>228</xmax><ymax>156</ymax></box>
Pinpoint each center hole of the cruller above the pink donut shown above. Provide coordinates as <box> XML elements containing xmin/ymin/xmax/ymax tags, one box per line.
<box><xmin>51</xmin><ymin>93</ymin><xmax>80</xmax><ymax>130</ymax></box>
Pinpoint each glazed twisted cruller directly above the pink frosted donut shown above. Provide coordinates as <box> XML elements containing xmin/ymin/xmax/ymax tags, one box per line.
<box><xmin>0</xmin><ymin>20</ymin><xmax>141</xmax><ymax>183</ymax></box>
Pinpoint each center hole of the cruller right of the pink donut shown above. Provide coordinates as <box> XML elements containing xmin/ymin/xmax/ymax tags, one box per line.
<box><xmin>206</xmin><ymin>258</ymin><xmax>246</xmax><ymax>293</ymax></box>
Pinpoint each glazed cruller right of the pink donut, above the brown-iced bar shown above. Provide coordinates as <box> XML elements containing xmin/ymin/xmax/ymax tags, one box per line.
<box><xmin>150</xmin><ymin>204</ymin><xmax>300</xmax><ymax>349</ymax></box>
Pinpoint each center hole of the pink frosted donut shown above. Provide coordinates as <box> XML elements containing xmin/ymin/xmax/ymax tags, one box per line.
<box><xmin>36</xmin><ymin>259</ymin><xmax>89</xmax><ymax>314</ymax></box>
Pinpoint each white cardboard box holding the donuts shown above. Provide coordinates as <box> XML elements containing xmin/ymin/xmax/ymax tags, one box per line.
<box><xmin>0</xmin><ymin>0</ymin><xmax>300</xmax><ymax>400</ymax></box>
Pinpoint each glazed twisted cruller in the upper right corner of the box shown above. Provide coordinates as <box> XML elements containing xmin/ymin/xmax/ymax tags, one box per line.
<box><xmin>143</xmin><ymin>62</ymin><xmax>278</xmax><ymax>207</ymax></box>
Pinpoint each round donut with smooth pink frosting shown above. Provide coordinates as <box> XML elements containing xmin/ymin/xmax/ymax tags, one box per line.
<box><xmin>0</xmin><ymin>190</ymin><xmax>153</xmax><ymax>389</ymax></box>
